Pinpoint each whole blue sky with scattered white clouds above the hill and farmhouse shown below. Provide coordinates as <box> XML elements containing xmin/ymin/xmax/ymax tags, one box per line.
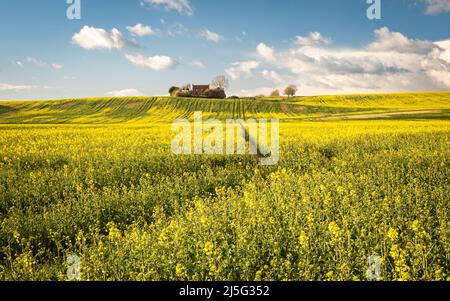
<box><xmin>0</xmin><ymin>0</ymin><xmax>450</xmax><ymax>99</ymax></box>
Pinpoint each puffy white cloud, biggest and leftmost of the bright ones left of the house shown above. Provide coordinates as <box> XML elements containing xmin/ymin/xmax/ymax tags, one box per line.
<box><xmin>72</xmin><ymin>25</ymin><xmax>137</xmax><ymax>50</ymax></box>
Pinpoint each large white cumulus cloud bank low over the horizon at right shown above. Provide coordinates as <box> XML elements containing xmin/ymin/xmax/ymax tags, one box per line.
<box><xmin>256</xmin><ymin>27</ymin><xmax>450</xmax><ymax>95</ymax></box>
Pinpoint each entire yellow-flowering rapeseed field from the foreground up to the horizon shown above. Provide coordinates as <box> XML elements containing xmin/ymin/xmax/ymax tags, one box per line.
<box><xmin>0</xmin><ymin>92</ymin><xmax>450</xmax><ymax>280</ymax></box>
